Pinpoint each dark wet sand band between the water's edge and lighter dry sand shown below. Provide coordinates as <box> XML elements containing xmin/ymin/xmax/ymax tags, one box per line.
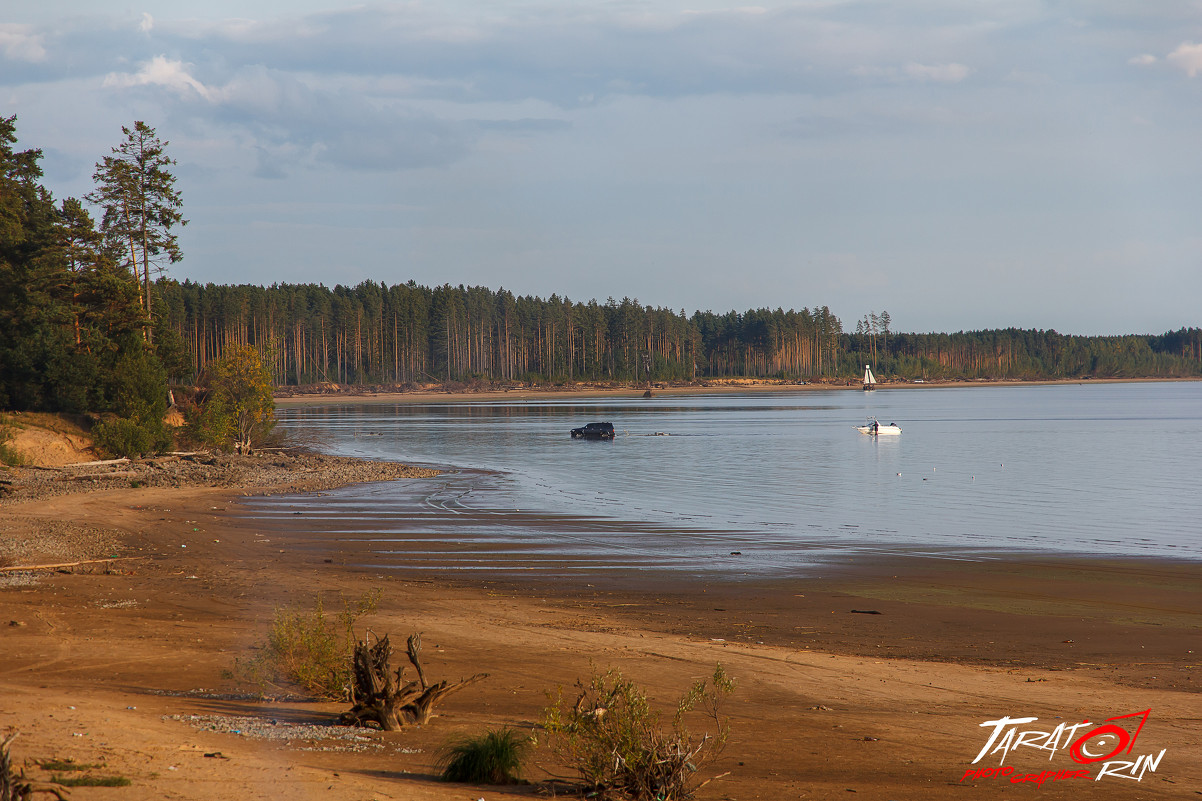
<box><xmin>227</xmin><ymin>485</ymin><xmax>1202</xmax><ymax>692</ymax></box>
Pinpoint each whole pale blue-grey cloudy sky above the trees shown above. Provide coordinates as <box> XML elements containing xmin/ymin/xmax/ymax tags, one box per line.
<box><xmin>7</xmin><ymin>0</ymin><xmax>1202</xmax><ymax>334</ymax></box>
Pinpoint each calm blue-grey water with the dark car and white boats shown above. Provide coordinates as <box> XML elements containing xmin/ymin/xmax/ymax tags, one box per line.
<box><xmin>248</xmin><ymin>382</ymin><xmax>1202</xmax><ymax>576</ymax></box>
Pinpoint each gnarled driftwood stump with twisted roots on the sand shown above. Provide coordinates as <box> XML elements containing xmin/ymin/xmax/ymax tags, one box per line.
<box><xmin>339</xmin><ymin>631</ymin><xmax>488</xmax><ymax>731</ymax></box>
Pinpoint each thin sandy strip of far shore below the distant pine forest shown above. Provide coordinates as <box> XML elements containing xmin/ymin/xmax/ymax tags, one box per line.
<box><xmin>275</xmin><ymin>378</ymin><xmax>1202</xmax><ymax>407</ymax></box>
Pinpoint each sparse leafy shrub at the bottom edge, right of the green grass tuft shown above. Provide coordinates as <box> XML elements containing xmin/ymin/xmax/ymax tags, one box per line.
<box><xmin>543</xmin><ymin>665</ymin><xmax>734</xmax><ymax>801</ymax></box>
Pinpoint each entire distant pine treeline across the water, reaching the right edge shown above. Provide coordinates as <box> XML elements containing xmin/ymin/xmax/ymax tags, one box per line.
<box><xmin>156</xmin><ymin>279</ymin><xmax>1202</xmax><ymax>385</ymax></box>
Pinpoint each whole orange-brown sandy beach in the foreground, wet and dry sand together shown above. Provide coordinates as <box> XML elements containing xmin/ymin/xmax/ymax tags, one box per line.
<box><xmin>0</xmin><ymin>452</ymin><xmax>1202</xmax><ymax>801</ymax></box>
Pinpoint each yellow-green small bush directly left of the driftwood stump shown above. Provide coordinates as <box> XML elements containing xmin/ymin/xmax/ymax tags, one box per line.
<box><xmin>234</xmin><ymin>589</ymin><xmax>381</xmax><ymax>700</ymax></box>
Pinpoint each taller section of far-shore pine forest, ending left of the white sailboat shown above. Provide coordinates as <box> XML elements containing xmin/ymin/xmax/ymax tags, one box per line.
<box><xmin>155</xmin><ymin>279</ymin><xmax>843</xmax><ymax>385</ymax></box>
